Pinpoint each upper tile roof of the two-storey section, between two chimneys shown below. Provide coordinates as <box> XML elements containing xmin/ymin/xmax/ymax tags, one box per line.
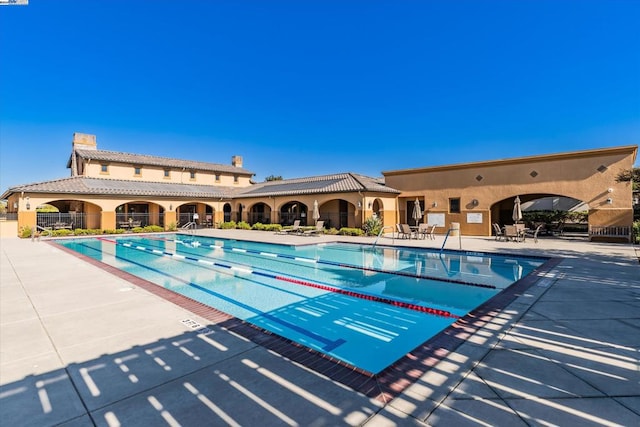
<box><xmin>67</xmin><ymin>149</ymin><xmax>255</xmax><ymax>176</ymax></box>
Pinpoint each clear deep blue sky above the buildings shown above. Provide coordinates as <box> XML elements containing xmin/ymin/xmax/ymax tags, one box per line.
<box><xmin>0</xmin><ymin>0</ymin><xmax>640</xmax><ymax>192</ymax></box>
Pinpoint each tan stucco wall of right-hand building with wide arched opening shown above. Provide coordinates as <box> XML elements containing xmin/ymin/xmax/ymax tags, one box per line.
<box><xmin>383</xmin><ymin>146</ymin><xmax>637</xmax><ymax>235</ymax></box>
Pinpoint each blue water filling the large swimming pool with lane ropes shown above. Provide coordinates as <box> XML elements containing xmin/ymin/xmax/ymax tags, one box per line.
<box><xmin>57</xmin><ymin>234</ymin><xmax>544</xmax><ymax>373</ymax></box>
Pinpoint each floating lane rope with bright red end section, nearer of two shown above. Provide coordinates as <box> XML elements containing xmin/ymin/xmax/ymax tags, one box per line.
<box><xmin>97</xmin><ymin>237</ymin><xmax>460</xmax><ymax>319</ymax></box>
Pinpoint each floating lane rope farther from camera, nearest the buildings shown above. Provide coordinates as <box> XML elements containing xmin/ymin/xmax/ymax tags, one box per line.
<box><xmin>169</xmin><ymin>239</ymin><xmax>498</xmax><ymax>289</ymax></box>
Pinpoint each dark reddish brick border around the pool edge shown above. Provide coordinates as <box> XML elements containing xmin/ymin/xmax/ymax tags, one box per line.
<box><xmin>47</xmin><ymin>240</ymin><xmax>561</xmax><ymax>403</ymax></box>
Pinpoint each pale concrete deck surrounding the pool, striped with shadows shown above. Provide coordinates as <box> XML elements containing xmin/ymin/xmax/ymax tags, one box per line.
<box><xmin>0</xmin><ymin>230</ymin><xmax>640</xmax><ymax>427</ymax></box>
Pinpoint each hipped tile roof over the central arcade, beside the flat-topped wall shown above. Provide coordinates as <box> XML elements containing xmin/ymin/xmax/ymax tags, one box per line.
<box><xmin>236</xmin><ymin>173</ymin><xmax>400</xmax><ymax>197</ymax></box>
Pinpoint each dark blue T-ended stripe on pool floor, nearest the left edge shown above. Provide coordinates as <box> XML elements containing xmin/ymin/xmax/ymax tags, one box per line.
<box><xmin>91</xmin><ymin>237</ymin><xmax>347</xmax><ymax>351</ymax></box>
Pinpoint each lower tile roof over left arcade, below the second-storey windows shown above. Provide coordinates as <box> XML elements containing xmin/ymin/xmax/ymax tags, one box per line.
<box><xmin>2</xmin><ymin>176</ymin><xmax>236</xmax><ymax>198</ymax></box>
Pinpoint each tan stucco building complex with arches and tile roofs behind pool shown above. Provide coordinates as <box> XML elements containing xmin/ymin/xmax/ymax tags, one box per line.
<box><xmin>1</xmin><ymin>133</ymin><xmax>637</xmax><ymax>240</ymax></box>
